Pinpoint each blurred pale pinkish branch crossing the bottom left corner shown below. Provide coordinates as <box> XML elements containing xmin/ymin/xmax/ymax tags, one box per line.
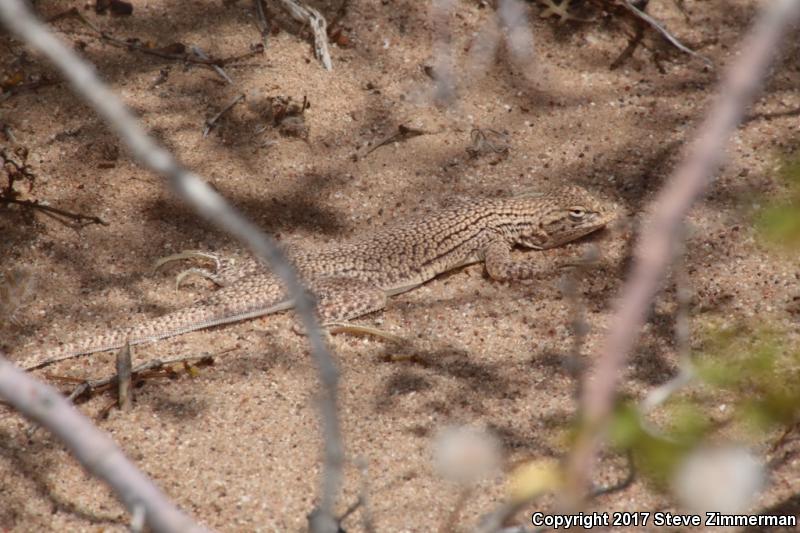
<box><xmin>0</xmin><ymin>352</ymin><xmax>208</xmax><ymax>533</ymax></box>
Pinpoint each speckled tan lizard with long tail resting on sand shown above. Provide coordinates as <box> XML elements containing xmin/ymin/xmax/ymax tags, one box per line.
<box><xmin>17</xmin><ymin>185</ymin><xmax>616</xmax><ymax>371</ymax></box>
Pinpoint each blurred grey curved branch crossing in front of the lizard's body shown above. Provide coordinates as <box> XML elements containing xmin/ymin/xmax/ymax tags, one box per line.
<box><xmin>0</xmin><ymin>0</ymin><xmax>344</xmax><ymax>533</ymax></box>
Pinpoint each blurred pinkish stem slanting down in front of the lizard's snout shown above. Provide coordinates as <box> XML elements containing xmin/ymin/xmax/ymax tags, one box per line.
<box><xmin>564</xmin><ymin>0</ymin><xmax>800</xmax><ymax>505</ymax></box>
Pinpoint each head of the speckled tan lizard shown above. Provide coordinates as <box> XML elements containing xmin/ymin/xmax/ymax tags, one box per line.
<box><xmin>514</xmin><ymin>185</ymin><xmax>617</xmax><ymax>250</ymax></box>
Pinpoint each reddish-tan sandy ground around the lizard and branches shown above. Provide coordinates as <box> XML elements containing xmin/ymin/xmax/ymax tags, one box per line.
<box><xmin>0</xmin><ymin>0</ymin><xmax>800</xmax><ymax>531</ymax></box>
